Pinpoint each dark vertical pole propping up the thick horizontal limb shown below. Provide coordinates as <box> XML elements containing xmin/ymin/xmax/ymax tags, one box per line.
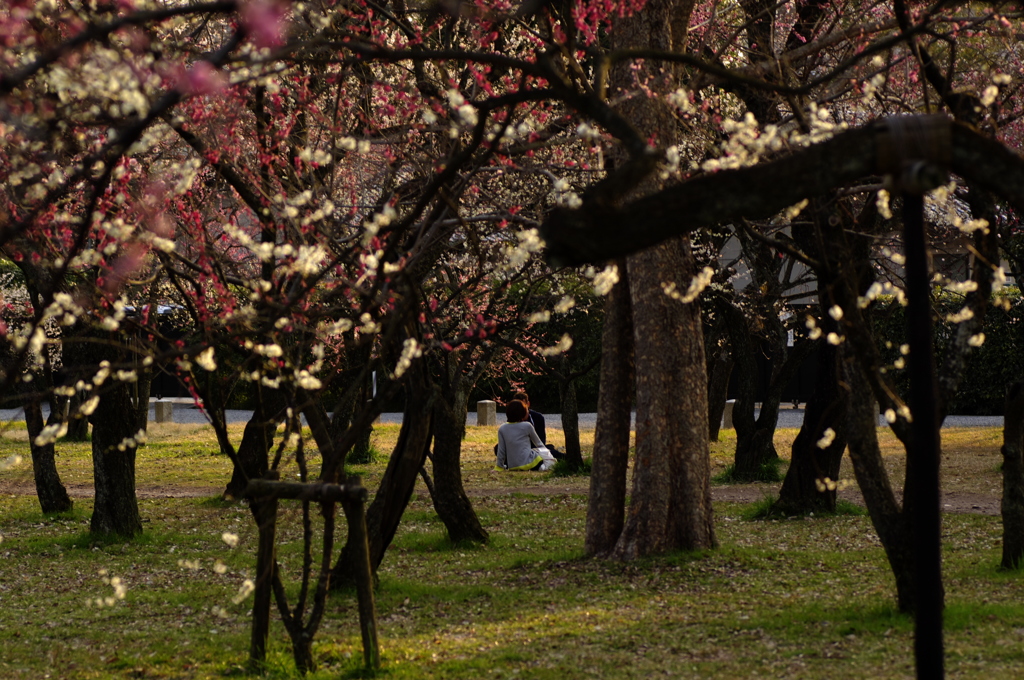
<box><xmin>903</xmin><ymin>192</ymin><xmax>944</xmax><ymax>680</ymax></box>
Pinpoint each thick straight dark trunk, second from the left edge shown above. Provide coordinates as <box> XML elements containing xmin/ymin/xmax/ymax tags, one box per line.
<box><xmin>89</xmin><ymin>380</ymin><xmax>142</xmax><ymax>537</ymax></box>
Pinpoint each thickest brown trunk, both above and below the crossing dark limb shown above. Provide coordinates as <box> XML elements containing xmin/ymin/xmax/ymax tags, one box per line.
<box><xmin>609</xmin><ymin>0</ymin><xmax>715</xmax><ymax>559</ymax></box>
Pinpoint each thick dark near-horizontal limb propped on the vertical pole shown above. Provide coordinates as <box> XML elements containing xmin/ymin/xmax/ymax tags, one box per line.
<box><xmin>541</xmin><ymin>116</ymin><xmax>1024</xmax><ymax>265</ymax></box>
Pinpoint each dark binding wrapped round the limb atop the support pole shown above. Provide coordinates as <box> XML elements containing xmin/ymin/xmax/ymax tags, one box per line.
<box><xmin>876</xmin><ymin>115</ymin><xmax>952</xmax><ymax>196</ymax></box>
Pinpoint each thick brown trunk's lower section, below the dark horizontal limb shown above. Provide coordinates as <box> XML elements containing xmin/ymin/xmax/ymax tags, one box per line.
<box><xmin>614</xmin><ymin>240</ymin><xmax>716</xmax><ymax>559</ymax></box>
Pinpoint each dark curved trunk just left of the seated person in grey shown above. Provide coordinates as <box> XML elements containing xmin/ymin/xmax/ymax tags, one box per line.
<box><xmin>431</xmin><ymin>376</ymin><xmax>489</xmax><ymax>543</ymax></box>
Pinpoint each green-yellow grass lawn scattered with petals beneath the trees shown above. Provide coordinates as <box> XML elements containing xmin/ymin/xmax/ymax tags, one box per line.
<box><xmin>0</xmin><ymin>425</ymin><xmax>1024</xmax><ymax>680</ymax></box>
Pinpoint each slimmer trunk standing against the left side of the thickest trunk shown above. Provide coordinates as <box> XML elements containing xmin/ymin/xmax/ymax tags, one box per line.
<box><xmin>584</xmin><ymin>261</ymin><xmax>636</xmax><ymax>555</ymax></box>
